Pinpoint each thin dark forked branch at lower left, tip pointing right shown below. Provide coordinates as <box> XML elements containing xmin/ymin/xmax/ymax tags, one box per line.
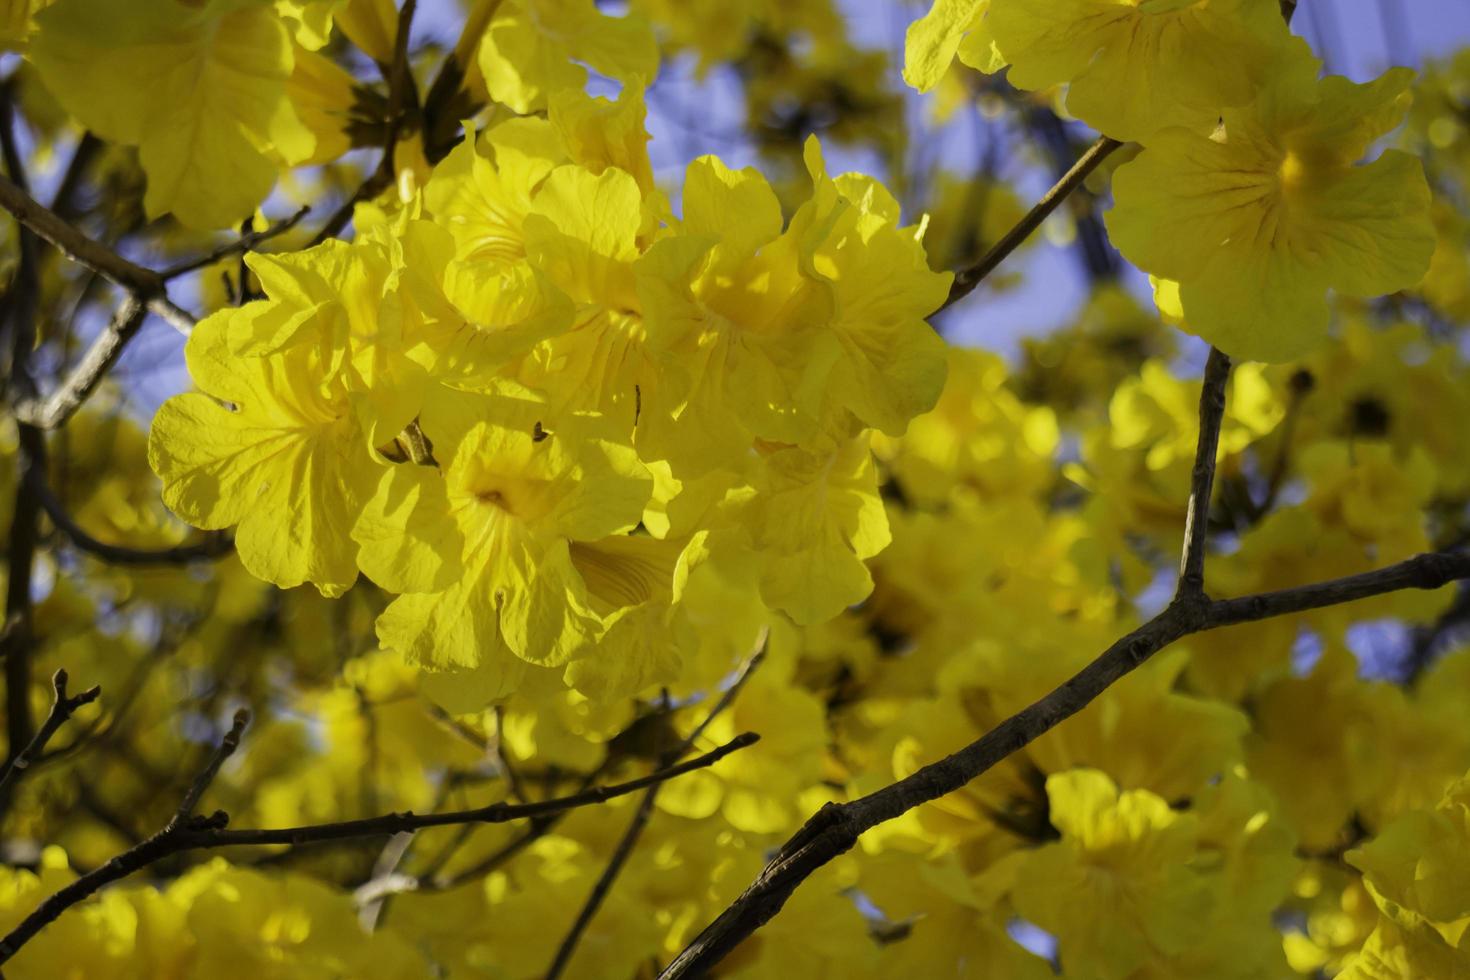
<box><xmin>0</xmin><ymin>728</ymin><xmax>760</xmax><ymax>964</ymax></box>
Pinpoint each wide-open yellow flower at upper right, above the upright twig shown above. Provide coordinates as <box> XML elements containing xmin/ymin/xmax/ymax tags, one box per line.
<box><xmin>1105</xmin><ymin>69</ymin><xmax>1435</xmax><ymax>360</ymax></box>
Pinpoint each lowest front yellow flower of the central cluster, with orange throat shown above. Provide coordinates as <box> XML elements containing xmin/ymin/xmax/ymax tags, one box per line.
<box><xmin>370</xmin><ymin>420</ymin><xmax>651</xmax><ymax>693</ymax></box>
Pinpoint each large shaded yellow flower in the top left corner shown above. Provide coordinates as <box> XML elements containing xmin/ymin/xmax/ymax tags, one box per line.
<box><xmin>29</xmin><ymin>0</ymin><xmax>316</xmax><ymax>228</ymax></box>
